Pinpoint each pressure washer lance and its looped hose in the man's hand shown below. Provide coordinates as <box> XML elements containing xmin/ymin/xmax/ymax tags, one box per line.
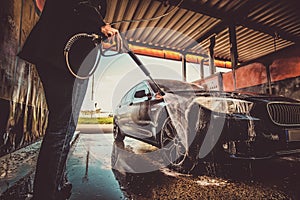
<box><xmin>64</xmin><ymin>33</ymin><xmax>165</xmax><ymax>96</ymax></box>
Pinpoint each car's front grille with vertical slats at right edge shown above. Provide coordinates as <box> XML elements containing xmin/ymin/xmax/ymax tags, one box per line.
<box><xmin>268</xmin><ymin>103</ymin><xmax>300</xmax><ymax>126</ymax></box>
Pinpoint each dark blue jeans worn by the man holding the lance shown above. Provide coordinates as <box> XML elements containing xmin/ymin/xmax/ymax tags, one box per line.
<box><xmin>33</xmin><ymin>65</ymin><xmax>88</xmax><ymax>200</ymax></box>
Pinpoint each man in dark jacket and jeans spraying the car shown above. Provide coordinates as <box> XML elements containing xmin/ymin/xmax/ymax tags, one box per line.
<box><xmin>19</xmin><ymin>0</ymin><xmax>118</xmax><ymax>200</ymax></box>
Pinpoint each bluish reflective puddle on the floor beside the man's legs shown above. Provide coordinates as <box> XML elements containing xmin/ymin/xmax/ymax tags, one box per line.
<box><xmin>67</xmin><ymin>134</ymin><xmax>125</xmax><ymax>200</ymax></box>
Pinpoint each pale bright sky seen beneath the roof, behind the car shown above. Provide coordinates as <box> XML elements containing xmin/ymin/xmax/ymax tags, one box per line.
<box><xmin>81</xmin><ymin>50</ymin><xmax>228</xmax><ymax>112</ymax></box>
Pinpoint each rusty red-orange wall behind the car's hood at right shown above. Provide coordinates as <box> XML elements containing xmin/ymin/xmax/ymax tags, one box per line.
<box><xmin>223</xmin><ymin>47</ymin><xmax>300</xmax><ymax>100</ymax></box>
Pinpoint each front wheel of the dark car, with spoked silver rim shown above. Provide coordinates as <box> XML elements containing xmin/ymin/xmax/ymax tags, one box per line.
<box><xmin>160</xmin><ymin>117</ymin><xmax>196</xmax><ymax>173</ymax></box>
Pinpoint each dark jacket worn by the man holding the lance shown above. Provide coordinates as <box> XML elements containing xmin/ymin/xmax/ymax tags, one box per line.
<box><xmin>18</xmin><ymin>0</ymin><xmax>106</xmax><ymax>69</ymax></box>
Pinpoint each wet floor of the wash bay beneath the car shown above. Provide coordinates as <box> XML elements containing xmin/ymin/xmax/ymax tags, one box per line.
<box><xmin>2</xmin><ymin>126</ymin><xmax>300</xmax><ymax>200</ymax></box>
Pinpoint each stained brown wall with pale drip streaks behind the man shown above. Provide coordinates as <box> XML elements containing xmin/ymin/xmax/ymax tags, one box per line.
<box><xmin>0</xmin><ymin>0</ymin><xmax>48</xmax><ymax>155</ymax></box>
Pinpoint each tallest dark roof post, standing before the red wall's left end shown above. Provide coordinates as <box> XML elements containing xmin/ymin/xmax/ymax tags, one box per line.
<box><xmin>229</xmin><ymin>24</ymin><xmax>238</xmax><ymax>91</ymax></box>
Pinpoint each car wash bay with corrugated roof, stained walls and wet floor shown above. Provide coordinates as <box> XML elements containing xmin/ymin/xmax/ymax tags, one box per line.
<box><xmin>0</xmin><ymin>0</ymin><xmax>300</xmax><ymax>199</ymax></box>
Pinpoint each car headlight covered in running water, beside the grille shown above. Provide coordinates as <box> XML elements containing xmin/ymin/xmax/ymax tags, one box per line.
<box><xmin>195</xmin><ymin>97</ymin><xmax>253</xmax><ymax>114</ymax></box>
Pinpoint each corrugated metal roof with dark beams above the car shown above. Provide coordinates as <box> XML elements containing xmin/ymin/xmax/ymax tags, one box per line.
<box><xmin>106</xmin><ymin>0</ymin><xmax>300</xmax><ymax>63</ymax></box>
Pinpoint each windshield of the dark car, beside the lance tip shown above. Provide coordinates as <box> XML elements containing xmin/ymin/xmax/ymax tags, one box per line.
<box><xmin>149</xmin><ymin>79</ymin><xmax>204</xmax><ymax>92</ymax></box>
